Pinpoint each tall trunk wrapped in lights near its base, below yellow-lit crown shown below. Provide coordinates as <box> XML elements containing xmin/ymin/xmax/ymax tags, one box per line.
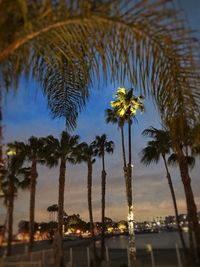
<box><xmin>127</xmin><ymin>116</ymin><xmax>136</xmax><ymax>267</ymax></box>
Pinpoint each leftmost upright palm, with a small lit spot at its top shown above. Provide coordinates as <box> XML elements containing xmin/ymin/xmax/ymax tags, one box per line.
<box><xmin>2</xmin><ymin>149</ymin><xmax>30</xmax><ymax>256</ymax></box>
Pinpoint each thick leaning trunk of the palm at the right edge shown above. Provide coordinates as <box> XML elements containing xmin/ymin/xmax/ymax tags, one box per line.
<box><xmin>178</xmin><ymin>152</ymin><xmax>200</xmax><ymax>259</ymax></box>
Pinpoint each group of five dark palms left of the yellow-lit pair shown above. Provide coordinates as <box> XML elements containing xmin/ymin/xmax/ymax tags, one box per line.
<box><xmin>1</xmin><ymin>131</ymin><xmax>114</xmax><ymax>262</ymax></box>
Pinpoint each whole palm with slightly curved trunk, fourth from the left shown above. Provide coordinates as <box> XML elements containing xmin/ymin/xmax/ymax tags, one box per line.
<box><xmin>75</xmin><ymin>143</ymin><xmax>96</xmax><ymax>258</ymax></box>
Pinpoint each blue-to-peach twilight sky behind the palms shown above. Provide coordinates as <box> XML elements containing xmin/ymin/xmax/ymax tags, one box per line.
<box><xmin>0</xmin><ymin>0</ymin><xmax>200</xmax><ymax>231</ymax></box>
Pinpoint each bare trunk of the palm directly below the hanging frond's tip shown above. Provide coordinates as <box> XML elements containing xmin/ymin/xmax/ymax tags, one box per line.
<box><xmin>58</xmin><ymin>159</ymin><xmax>66</xmax><ymax>237</ymax></box>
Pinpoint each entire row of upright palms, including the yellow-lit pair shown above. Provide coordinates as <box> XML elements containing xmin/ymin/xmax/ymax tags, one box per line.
<box><xmin>2</xmin><ymin>88</ymin><xmax>199</xmax><ymax>266</ymax></box>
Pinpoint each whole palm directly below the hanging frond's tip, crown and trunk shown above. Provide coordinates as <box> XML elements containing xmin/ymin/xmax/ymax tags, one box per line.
<box><xmin>44</xmin><ymin>131</ymin><xmax>79</xmax><ymax>236</ymax></box>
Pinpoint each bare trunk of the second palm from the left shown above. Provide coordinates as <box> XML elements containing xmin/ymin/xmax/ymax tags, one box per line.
<box><xmin>29</xmin><ymin>160</ymin><xmax>37</xmax><ymax>251</ymax></box>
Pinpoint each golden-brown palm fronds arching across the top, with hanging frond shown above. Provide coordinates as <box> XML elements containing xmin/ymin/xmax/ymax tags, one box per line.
<box><xmin>0</xmin><ymin>0</ymin><xmax>199</xmax><ymax>135</ymax></box>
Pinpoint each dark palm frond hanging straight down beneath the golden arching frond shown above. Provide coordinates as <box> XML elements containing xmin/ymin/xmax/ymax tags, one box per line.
<box><xmin>34</xmin><ymin>58</ymin><xmax>89</xmax><ymax>129</ymax></box>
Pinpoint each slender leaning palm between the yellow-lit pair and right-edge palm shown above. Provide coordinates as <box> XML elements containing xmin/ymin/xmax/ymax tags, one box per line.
<box><xmin>141</xmin><ymin>127</ymin><xmax>187</xmax><ymax>255</ymax></box>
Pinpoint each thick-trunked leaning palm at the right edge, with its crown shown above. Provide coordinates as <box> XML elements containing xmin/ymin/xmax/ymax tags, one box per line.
<box><xmin>166</xmin><ymin>117</ymin><xmax>200</xmax><ymax>259</ymax></box>
